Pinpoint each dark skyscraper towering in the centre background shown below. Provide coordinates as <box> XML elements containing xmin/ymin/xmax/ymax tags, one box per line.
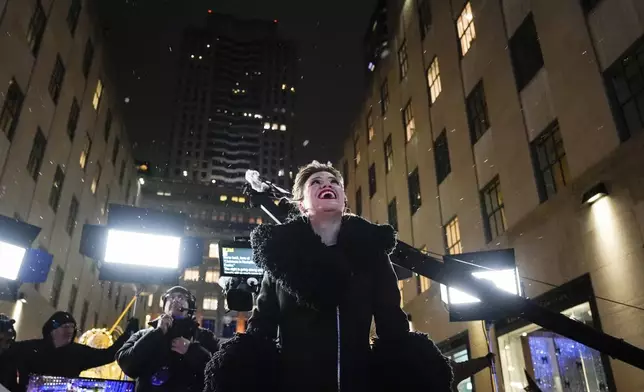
<box><xmin>168</xmin><ymin>13</ymin><xmax>297</xmax><ymax>191</ymax></box>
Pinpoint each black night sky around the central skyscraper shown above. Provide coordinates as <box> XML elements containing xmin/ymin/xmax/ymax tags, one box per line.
<box><xmin>99</xmin><ymin>0</ymin><xmax>376</xmax><ymax>172</ymax></box>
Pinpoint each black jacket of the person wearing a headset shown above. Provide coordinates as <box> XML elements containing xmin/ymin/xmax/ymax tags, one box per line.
<box><xmin>116</xmin><ymin>319</ymin><xmax>219</xmax><ymax>392</ymax></box>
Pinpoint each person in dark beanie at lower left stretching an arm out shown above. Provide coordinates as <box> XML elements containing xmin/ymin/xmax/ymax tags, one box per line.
<box><xmin>0</xmin><ymin>311</ymin><xmax>139</xmax><ymax>392</ymax></box>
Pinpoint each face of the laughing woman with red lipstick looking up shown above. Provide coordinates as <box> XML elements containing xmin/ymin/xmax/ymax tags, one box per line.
<box><xmin>300</xmin><ymin>172</ymin><xmax>345</xmax><ymax>217</ymax></box>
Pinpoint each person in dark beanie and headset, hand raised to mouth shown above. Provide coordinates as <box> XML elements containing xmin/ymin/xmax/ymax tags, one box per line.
<box><xmin>116</xmin><ymin>286</ymin><xmax>219</xmax><ymax>392</ymax></box>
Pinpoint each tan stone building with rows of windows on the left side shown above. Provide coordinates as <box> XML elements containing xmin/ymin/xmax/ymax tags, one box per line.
<box><xmin>0</xmin><ymin>0</ymin><xmax>142</xmax><ymax>339</ymax></box>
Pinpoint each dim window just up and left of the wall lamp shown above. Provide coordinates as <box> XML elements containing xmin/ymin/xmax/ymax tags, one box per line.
<box><xmin>532</xmin><ymin>121</ymin><xmax>570</xmax><ymax>202</ymax></box>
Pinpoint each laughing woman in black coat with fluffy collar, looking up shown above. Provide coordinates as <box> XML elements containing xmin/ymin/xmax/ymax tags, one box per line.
<box><xmin>205</xmin><ymin>162</ymin><xmax>452</xmax><ymax>392</ymax></box>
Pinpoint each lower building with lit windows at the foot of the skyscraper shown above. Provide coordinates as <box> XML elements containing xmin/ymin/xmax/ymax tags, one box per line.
<box><xmin>140</xmin><ymin>177</ymin><xmax>266</xmax><ymax>337</ymax></box>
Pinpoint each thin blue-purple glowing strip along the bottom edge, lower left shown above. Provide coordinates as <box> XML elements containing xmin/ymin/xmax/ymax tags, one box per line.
<box><xmin>27</xmin><ymin>376</ymin><xmax>134</xmax><ymax>392</ymax></box>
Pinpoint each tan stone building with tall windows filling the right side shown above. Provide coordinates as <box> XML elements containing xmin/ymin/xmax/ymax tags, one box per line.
<box><xmin>340</xmin><ymin>0</ymin><xmax>644</xmax><ymax>392</ymax></box>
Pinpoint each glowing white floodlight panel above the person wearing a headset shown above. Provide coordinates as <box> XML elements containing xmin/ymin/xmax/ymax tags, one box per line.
<box><xmin>105</xmin><ymin>229</ymin><xmax>181</xmax><ymax>268</ymax></box>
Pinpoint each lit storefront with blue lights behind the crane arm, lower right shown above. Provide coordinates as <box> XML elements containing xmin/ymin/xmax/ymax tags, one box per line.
<box><xmin>494</xmin><ymin>275</ymin><xmax>615</xmax><ymax>392</ymax></box>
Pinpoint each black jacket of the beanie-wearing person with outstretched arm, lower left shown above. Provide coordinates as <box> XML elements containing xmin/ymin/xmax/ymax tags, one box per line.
<box><xmin>0</xmin><ymin>334</ymin><xmax>129</xmax><ymax>392</ymax></box>
